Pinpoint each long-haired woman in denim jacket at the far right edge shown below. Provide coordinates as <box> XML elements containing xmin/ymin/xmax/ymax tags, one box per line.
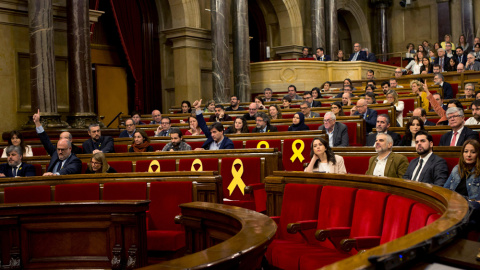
<box><xmin>443</xmin><ymin>140</ymin><xmax>480</xmax><ymax>201</ymax></box>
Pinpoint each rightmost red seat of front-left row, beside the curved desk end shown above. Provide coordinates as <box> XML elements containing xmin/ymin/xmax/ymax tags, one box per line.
<box><xmin>147</xmin><ymin>182</ymin><xmax>193</xmax><ymax>251</ymax></box>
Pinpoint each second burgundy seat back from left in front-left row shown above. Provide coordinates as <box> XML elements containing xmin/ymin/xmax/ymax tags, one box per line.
<box><xmin>55</xmin><ymin>183</ymin><xmax>100</xmax><ymax>202</ymax></box>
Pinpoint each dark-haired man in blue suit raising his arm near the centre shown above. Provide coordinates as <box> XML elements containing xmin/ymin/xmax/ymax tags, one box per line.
<box><xmin>192</xmin><ymin>99</ymin><xmax>234</xmax><ymax>151</ymax></box>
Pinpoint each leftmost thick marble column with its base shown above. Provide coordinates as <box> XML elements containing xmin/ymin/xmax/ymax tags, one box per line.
<box><xmin>26</xmin><ymin>0</ymin><xmax>68</xmax><ymax>128</ymax></box>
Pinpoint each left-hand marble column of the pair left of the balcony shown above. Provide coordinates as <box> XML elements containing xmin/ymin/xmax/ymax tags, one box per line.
<box><xmin>211</xmin><ymin>0</ymin><xmax>230</xmax><ymax>102</ymax></box>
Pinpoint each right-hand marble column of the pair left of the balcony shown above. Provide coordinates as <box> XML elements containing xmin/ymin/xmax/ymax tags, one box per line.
<box><xmin>232</xmin><ymin>0</ymin><xmax>250</xmax><ymax>101</ymax></box>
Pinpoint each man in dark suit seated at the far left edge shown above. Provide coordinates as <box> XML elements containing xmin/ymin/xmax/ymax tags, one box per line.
<box><xmin>0</xmin><ymin>145</ymin><xmax>35</xmax><ymax>177</ymax></box>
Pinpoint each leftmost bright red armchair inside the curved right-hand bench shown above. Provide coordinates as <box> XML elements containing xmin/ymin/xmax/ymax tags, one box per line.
<box><xmin>265</xmin><ymin>184</ymin><xmax>322</xmax><ymax>263</ymax></box>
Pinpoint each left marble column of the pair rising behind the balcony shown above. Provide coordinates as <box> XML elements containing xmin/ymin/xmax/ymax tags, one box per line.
<box><xmin>311</xmin><ymin>0</ymin><xmax>325</xmax><ymax>55</ymax></box>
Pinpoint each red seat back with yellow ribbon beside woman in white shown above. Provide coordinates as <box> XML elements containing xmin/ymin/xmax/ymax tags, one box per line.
<box><xmin>282</xmin><ymin>138</ymin><xmax>313</xmax><ymax>171</ymax></box>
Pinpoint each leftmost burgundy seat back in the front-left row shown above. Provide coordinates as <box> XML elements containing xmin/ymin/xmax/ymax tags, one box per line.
<box><xmin>4</xmin><ymin>185</ymin><xmax>51</xmax><ymax>203</ymax></box>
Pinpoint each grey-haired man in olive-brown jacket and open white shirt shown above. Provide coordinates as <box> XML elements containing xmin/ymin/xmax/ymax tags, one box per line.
<box><xmin>365</xmin><ymin>133</ymin><xmax>408</xmax><ymax>178</ymax></box>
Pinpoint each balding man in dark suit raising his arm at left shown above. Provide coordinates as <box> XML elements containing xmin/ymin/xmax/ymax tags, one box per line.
<box><xmin>33</xmin><ymin>111</ymin><xmax>82</xmax><ymax>176</ymax></box>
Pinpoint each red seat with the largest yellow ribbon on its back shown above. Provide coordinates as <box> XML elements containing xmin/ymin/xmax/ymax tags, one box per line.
<box><xmin>220</xmin><ymin>157</ymin><xmax>267</xmax><ymax>212</ymax></box>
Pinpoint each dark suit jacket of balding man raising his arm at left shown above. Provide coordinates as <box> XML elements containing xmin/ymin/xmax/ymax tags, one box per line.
<box><xmin>38</xmin><ymin>132</ymin><xmax>82</xmax><ymax>175</ymax></box>
